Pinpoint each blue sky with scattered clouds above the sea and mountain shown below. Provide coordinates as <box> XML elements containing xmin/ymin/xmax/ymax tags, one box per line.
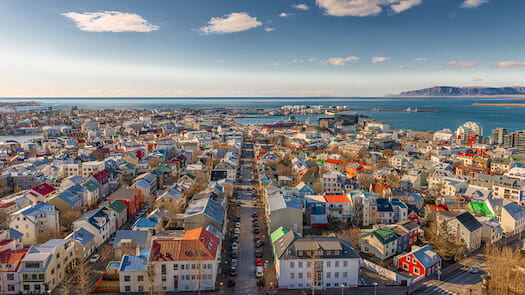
<box><xmin>0</xmin><ymin>0</ymin><xmax>525</xmax><ymax>97</ymax></box>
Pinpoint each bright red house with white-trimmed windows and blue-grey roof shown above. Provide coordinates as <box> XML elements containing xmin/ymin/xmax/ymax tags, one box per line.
<box><xmin>398</xmin><ymin>246</ymin><xmax>441</xmax><ymax>277</ymax></box>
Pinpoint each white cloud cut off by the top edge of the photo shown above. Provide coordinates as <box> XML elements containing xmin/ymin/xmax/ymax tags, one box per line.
<box><xmin>315</xmin><ymin>0</ymin><xmax>423</xmax><ymax>16</ymax></box>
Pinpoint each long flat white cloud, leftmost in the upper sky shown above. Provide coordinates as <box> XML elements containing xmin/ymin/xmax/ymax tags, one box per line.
<box><xmin>62</xmin><ymin>11</ymin><xmax>159</xmax><ymax>32</ymax></box>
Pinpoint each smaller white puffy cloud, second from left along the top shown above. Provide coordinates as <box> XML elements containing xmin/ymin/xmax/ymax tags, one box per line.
<box><xmin>199</xmin><ymin>12</ymin><xmax>262</xmax><ymax>34</ymax></box>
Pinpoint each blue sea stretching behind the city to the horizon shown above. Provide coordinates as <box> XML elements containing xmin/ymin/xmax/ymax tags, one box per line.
<box><xmin>0</xmin><ymin>97</ymin><xmax>525</xmax><ymax>135</ymax></box>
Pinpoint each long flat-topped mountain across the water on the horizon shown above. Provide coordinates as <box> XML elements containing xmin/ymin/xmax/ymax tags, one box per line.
<box><xmin>396</xmin><ymin>86</ymin><xmax>525</xmax><ymax>97</ymax></box>
